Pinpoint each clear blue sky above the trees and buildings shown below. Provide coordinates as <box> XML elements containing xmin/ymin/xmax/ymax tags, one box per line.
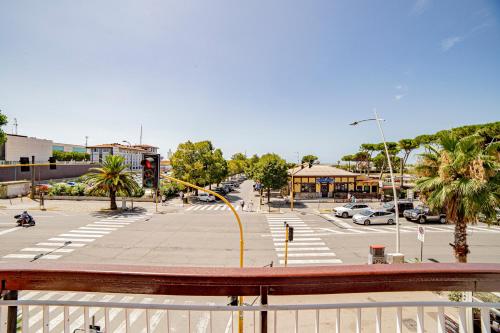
<box><xmin>0</xmin><ymin>0</ymin><xmax>500</xmax><ymax>162</ymax></box>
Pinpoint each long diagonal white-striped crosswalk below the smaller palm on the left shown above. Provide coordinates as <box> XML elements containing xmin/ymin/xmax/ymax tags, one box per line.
<box><xmin>3</xmin><ymin>213</ymin><xmax>152</xmax><ymax>261</ymax></box>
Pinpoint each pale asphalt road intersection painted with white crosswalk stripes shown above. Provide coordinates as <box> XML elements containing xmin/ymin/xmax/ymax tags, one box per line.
<box><xmin>0</xmin><ymin>184</ymin><xmax>500</xmax><ymax>332</ymax></box>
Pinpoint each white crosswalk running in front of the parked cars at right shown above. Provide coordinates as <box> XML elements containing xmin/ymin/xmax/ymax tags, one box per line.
<box><xmin>318</xmin><ymin>214</ymin><xmax>500</xmax><ymax>235</ymax></box>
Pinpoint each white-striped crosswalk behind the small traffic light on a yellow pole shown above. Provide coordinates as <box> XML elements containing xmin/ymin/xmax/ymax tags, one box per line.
<box><xmin>267</xmin><ymin>216</ymin><xmax>342</xmax><ymax>266</ymax></box>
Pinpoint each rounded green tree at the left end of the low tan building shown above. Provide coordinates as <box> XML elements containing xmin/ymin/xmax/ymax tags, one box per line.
<box><xmin>253</xmin><ymin>154</ymin><xmax>288</xmax><ymax>204</ymax></box>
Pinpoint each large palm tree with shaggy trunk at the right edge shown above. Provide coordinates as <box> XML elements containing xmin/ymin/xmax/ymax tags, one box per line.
<box><xmin>416</xmin><ymin>133</ymin><xmax>500</xmax><ymax>263</ymax></box>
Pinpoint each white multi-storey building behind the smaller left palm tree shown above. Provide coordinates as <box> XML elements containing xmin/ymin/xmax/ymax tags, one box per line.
<box><xmin>88</xmin><ymin>143</ymin><xmax>148</xmax><ymax>171</ymax></box>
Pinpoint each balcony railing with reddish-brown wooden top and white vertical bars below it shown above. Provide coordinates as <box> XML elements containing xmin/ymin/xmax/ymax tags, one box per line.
<box><xmin>0</xmin><ymin>262</ymin><xmax>500</xmax><ymax>332</ymax></box>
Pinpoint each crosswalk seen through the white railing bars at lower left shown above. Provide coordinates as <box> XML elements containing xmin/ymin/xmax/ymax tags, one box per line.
<box><xmin>10</xmin><ymin>291</ymin><xmax>228</xmax><ymax>333</ymax></box>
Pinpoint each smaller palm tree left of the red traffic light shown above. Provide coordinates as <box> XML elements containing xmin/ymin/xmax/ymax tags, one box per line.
<box><xmin>85</xmin><ymin>155</ymin><xmax>139</xmax><ymax>210</ymax></box>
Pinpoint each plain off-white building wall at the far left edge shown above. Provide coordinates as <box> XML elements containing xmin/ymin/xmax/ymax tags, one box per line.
<box><xmin>5</xmin><ymin>135</ymin><xmax>52</xmax><ymax>163</ymax></box>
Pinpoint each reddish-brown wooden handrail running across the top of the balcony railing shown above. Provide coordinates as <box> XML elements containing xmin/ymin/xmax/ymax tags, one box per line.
<box><xmin>0</xmin><ymin>262</ymin><xmax>500</xmax><ymax>296</ymax></box>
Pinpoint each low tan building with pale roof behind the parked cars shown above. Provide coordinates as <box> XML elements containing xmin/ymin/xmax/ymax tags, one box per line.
<box><xmin>288</xmin><ymin>165</ymin><xmax>378</xmax><ymax>199</ymax></box>
